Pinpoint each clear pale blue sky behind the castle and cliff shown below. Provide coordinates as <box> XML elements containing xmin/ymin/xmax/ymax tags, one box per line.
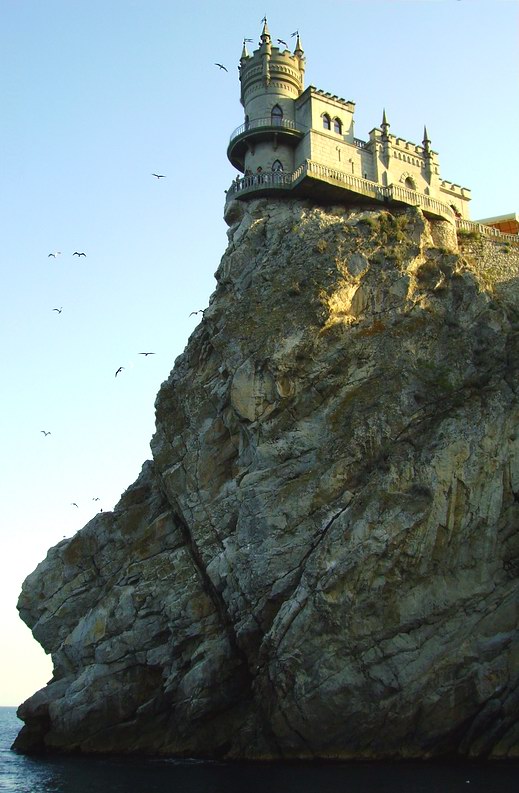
<box><xmin>0</xmin><ymin>0</ymin><xmax>519</xmax><ymax>705</ymax></box>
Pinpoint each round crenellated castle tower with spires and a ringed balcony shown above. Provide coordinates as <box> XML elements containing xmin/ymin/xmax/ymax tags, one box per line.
<box><xmin>227</xmin><ymin>18</ymin><xmax>305</xmax><ymax>174</ymax></box>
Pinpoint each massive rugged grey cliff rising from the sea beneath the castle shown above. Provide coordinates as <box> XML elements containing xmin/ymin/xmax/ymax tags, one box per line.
<box><xmin>15</xmin><ymin>199</ymin><xmax>519</xmax><ymax>758</ymax></box>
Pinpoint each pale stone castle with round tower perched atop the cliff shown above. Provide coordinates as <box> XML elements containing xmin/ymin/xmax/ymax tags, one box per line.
<box><xmin>227</xmin><ymin>18</ymin><xmax>470</xmax><ymax>223</ymax></box>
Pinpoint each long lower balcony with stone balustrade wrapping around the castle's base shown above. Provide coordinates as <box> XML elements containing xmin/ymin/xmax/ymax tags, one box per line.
<box><xmin>226</xmin><ymin>160</ymin><xmax>455</xmax><ymax>223</ymax></box>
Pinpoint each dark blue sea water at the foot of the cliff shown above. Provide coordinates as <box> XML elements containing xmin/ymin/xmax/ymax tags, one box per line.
<box><xmin>0</xmin><ymin>708</ymin><xmax>519</xmax><ymax>793</ymax></box>
